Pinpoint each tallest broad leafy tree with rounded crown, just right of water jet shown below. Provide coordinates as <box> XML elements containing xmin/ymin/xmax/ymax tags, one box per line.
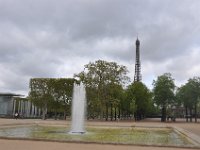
<box><xmin>75</xmin><ymin>60</ymin><xmax>129</xmax><ymax>120</ymax></box>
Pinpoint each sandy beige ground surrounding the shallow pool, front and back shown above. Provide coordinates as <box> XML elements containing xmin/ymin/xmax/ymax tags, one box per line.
<box><xmin>0</xmin><ymin>119</ymin><xmax>200</xmax><ymax>150</ymax></box>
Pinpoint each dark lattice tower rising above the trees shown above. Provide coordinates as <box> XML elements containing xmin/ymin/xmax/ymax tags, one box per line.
<box><xmin>134</xmin><ymin>38</ymin><xmax>142</xmax><ymax>82</ymax></box>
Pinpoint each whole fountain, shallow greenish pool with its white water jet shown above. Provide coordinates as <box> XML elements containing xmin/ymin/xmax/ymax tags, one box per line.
<box><xmin>0</xmin><ymin>83</ymin><xmax>196</xmax><ymax>149</ymax></box>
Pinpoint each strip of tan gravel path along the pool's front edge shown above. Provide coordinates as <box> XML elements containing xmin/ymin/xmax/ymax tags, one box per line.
<box><xmin>0</xmin><ymin>139</ymin><xmax>197</xmax><ymax>150</ymax></box>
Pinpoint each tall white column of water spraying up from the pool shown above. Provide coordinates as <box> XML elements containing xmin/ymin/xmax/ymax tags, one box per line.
<box><xmin>70</xmin><ymin>83</ymin><xmax>86</xmax><ymax>134</ymax></box>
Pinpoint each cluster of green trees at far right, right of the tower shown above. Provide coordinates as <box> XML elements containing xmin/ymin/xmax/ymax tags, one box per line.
<box><xmin>153</xmin><ymin>73</ymin><xmax>200</xmax><ymax>122</ymax></box>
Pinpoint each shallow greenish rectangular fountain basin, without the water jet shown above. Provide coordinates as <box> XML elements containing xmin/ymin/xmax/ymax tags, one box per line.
<box><xmin>0</xmin><ymin>125</ymin><xmax>199</xmax><ymax>147</ymax></box>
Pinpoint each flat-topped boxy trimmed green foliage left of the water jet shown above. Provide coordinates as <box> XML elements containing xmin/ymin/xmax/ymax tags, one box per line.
<box><xmin>29</xmin><ymin>78</ymin><xmax>75</xmax><ymax>119</ymax></box>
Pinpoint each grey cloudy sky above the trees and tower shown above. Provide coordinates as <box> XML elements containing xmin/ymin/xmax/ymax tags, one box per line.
<box><xmin>0</xmin><ymin>0</ymin><xmax>200</xmax><ymax>95</ymax></box>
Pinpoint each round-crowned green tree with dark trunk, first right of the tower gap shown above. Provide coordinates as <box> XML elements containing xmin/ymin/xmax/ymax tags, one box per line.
<box><xmin>153</xmin><ymin>73</ymin><xmax>175</xmax><ymax>121</ymax></box>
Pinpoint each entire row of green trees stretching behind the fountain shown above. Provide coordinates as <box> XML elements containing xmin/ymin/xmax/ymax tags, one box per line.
<box><xmin>29</xmin><ymin>60</ymin><xmax>200</xmax><ymax>121</ymax></box>
